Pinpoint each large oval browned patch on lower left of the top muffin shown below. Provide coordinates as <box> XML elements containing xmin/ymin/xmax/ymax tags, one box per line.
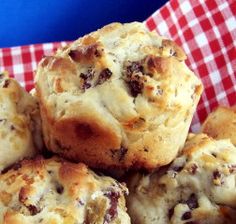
<box><xmin>48</xmin><ymin>117</ymin><xmax>121</xmax><ymax>164</ymax></box>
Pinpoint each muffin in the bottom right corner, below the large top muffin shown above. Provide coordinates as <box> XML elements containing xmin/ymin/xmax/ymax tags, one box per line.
<box><xmin>127</xmin><ymin>134</ymin><xmax>236</xmax><ymax>224</ymax></box>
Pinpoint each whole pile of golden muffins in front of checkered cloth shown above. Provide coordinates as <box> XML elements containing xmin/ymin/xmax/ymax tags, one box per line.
<box><xmin>0</xmin><ymin>22</ymin><xmax>236</xmax><ymax>224</ymax></box>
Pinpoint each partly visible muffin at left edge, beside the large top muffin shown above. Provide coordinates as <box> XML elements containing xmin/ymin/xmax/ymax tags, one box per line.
<box><xmin>0</xmin><ymin>74</ymin><xmax>42</xmax><ymax>172</ymax></box>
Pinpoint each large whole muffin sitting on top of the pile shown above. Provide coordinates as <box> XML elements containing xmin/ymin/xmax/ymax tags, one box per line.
<box><xmin>35</xmin><ymin>23</ymin><xmax>202</xmax><ymax>169</ymax></box>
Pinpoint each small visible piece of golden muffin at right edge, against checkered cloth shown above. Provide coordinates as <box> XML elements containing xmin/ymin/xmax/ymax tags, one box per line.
<box><xmin>202</xmin><ymin>106</ymin><xmax>236</xmax><ymax>145</ymax></box>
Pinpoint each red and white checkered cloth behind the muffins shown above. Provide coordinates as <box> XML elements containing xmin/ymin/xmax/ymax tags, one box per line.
<box><xmin>0</xmin><ymin>0</ymin><xmax>236</xmax><ymax>131</ymax></box>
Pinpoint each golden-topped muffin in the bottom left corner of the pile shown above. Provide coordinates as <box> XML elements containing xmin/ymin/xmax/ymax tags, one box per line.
<box><xmin>0</xmin><ymin>158</ymin><xmax>130</xmax><ymax>224</ymax></box>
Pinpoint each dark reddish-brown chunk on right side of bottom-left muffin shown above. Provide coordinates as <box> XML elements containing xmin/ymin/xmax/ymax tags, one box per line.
<box><xmin>103</xmin><ymin>191</ymin><xmax>120</xmax><ymax>224</ymax></box>
